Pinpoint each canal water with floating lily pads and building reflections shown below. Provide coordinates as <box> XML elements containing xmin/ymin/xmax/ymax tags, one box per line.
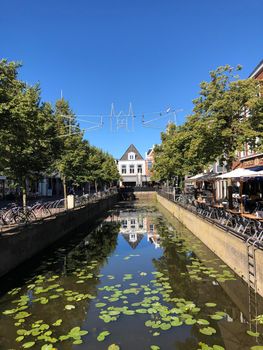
<box><xmin>0</xmin><ymin>202</ymin><xmax>263</xmax><ymax>350</ymax></box>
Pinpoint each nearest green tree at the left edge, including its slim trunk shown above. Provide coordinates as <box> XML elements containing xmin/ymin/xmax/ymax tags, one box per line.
<box><xmin>0</xmin><ymin>60</ymin><xmax>55</xmax><ymax>206</ymax></box>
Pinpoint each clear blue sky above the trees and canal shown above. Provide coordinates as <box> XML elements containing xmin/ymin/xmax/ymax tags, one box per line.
<box><xmin>0</xmin><ymin>0</ymin><xmax>263</xmax><ymax>158</ymax></box>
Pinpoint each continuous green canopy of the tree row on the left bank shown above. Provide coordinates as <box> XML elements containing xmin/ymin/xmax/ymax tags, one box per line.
<box><xmin>0</xmin><ymin>60</ymin><xmax>118</xmax><ymax>204</ymax></box>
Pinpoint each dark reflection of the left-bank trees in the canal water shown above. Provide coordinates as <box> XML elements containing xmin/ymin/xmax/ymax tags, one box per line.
<box><xmin>0</xmin><ymin>223</ymin><xmax>119</xmax><ymax>350</ymax></box>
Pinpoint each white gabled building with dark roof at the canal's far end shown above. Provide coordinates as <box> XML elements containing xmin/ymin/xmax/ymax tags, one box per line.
<box><xmin>118</xmin><ymin>145</ymin><xmax>147</xmax><ymax>186</ymax></box>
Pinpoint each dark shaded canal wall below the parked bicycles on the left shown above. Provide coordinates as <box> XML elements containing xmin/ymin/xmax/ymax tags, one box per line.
<box><xmin>0</xmin><ymin>194</ymin><xmax>118</xmax><ymax>277</ymax></box>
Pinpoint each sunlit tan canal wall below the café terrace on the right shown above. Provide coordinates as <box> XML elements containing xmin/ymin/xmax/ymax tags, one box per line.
<box><xmin>156</xmin><ymin>194</ymin><xmax>263</xmax><ymax>296</ymax></box>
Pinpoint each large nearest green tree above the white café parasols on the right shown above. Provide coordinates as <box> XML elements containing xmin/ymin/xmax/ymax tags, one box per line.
<box><xmin>191</xmin><ymin>65</ymin><xmax>263</xmax><ymax>168</ymax></box>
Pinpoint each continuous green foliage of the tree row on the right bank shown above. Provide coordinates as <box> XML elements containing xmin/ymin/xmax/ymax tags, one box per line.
<box><xmin>154</xmin><ymin>65</ymin><xmax>263</xmax><ymax>180</ymax></box>
